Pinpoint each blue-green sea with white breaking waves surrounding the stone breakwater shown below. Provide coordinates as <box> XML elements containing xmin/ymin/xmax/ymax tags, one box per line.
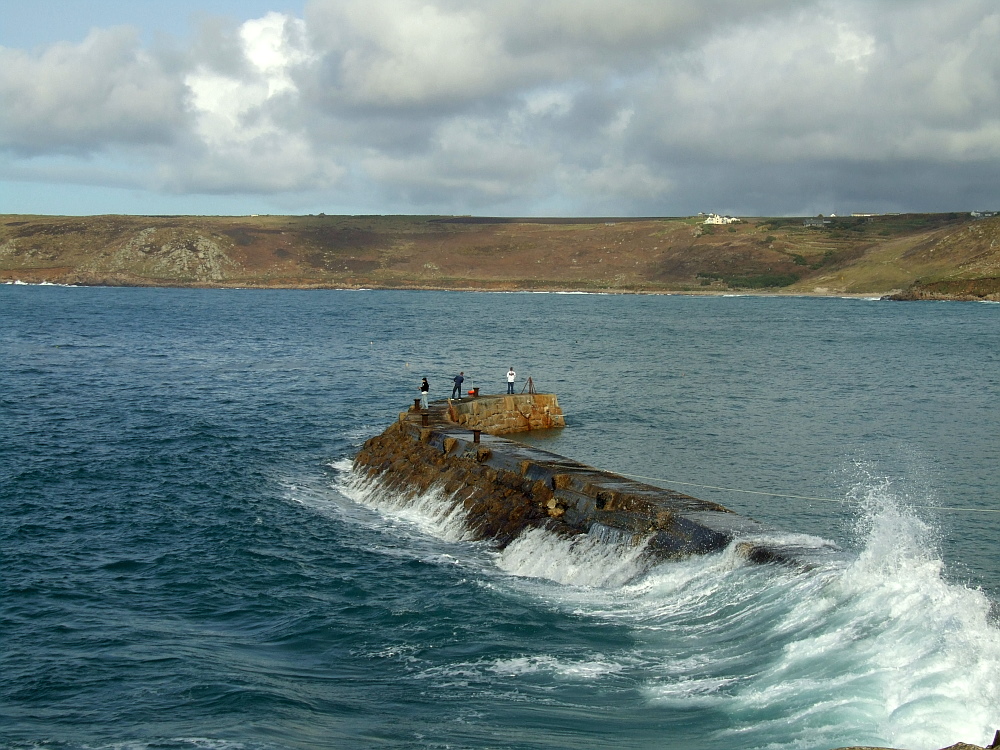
<box><xmin>0</xmin><ymin>285</ymin><xmax>1000</xmax><ymax>750</ymax></box>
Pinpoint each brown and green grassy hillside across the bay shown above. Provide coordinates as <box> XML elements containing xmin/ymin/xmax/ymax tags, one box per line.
<box><xmin>0</xmin><ymin>214</ymin><xmax>1000</xmax><ymax>299</ymax></box>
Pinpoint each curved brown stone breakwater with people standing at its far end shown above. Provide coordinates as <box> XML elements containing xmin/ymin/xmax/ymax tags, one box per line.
<box><xmin>354</xmin><ymin>394</ymin><xmax>828</xmax><ymax>563</ymax></box>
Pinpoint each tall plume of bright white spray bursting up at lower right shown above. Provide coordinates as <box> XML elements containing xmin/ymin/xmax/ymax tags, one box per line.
<box><xmin>835</xmin><ymin>479</ymin><xmax>1000</xmax><ymax>748</ymax></box>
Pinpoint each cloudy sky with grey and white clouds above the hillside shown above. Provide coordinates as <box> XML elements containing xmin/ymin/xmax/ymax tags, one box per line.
<box><xmin>0</xmin><ymin>0</ymin><xmax>1000</xmax><ymax>216</ymax></box>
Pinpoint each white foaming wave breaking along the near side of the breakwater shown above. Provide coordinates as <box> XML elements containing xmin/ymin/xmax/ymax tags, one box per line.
<box><xmin>328</xmin><ymin>468</ymin><xmax>1000</xmax><ymax>750</ymax></box>
